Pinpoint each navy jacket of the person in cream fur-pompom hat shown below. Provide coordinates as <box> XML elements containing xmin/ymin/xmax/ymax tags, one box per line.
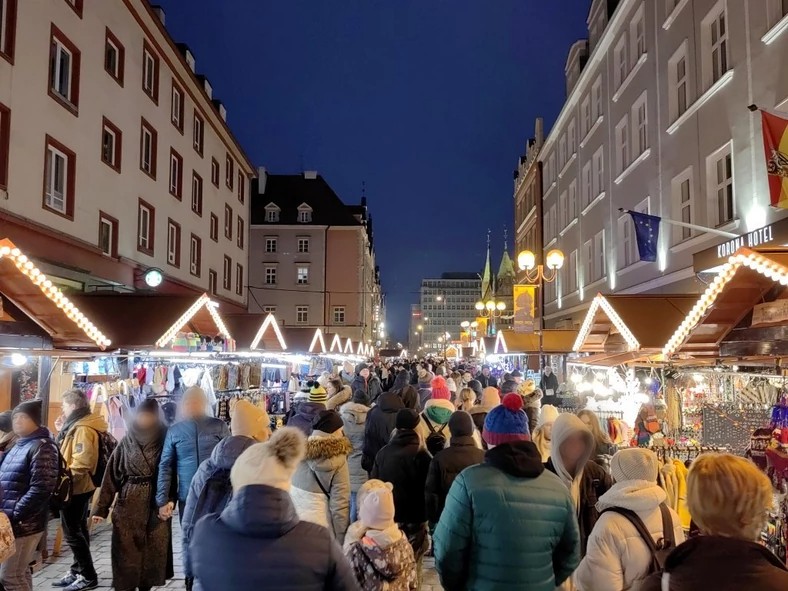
<box><xmin>191</xmin><ymin>485</ymin><xmax>358</xmax><ymax>591</ymax></box>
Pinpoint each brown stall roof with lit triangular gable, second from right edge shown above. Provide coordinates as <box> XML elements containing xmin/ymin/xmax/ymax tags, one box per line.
<box><xmin>572</xmin><ymin>294</ymin><xmax>697</xmax><ymax>353</ymax></box>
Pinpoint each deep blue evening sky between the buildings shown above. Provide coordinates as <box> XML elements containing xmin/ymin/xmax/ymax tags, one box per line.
<box><xmin>160</xmin><ymin>0</ymin><xmax>590</xmax><ymax>339</ymax></box>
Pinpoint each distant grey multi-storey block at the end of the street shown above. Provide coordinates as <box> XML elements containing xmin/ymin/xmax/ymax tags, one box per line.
<box><xmin>418</xmin><ymin>273</ymin><xmax>482</xmax><ymax>352</ymax></box>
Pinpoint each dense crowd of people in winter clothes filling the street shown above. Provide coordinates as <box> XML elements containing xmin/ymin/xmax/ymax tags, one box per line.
<box><xmin>0</xmin><ymin>360</ymin><xmax>788</xmax><ymax>591</ymax></box>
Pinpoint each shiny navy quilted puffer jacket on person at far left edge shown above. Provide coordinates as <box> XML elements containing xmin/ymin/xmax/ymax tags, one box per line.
<box><xmin>0</xmin><ymin>427</ymin><xmax>59</xmax><ymax>538</ymax></box>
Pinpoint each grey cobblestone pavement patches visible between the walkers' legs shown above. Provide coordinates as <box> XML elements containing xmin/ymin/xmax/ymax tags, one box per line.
<box><xmin>33</xmin><ymin>517</ymin><xmax>443</xmax><ymax>591</ymax></box>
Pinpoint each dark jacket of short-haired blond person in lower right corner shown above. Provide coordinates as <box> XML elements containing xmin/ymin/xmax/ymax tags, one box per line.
<box><xmin>639</xmin><ymin>536</ymin><xmax>788</xmax><ymax>591</ymax></box>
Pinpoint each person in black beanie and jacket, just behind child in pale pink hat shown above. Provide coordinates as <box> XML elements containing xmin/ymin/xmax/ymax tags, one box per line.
<box><xmin>370</xmin><ymin>408</ymin><xmax>432</xmax><ymax>564</ymax></box>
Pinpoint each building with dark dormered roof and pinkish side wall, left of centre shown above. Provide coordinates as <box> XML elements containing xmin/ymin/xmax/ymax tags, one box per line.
<box><xmin>249</xmin><ymin>169</ymin><xmax>385</xmax><ymax>343</ymax></box>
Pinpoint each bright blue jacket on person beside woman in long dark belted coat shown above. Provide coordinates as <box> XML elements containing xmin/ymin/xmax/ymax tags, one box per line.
<box><xmin>156</xmin><ymin>417</ymin><xmax>230</xmax><ymax>507</ymax></box>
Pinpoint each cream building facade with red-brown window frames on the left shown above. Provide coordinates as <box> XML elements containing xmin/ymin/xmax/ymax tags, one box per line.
<box><xmin>0</xmin><ymin>0</ymin><xmax>254</xmax><ymax>308</ymax></box>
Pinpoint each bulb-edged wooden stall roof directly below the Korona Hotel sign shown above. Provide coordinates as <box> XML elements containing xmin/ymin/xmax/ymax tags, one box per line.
<box><xmin>662</xmin><ymin>248</ymin><xmax>788</xmax><ymax>358</ymax></box>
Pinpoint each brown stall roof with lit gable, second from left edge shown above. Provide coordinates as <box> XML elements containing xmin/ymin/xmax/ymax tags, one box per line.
<box><xmin>74</xmin><ymin>293</ymin><xmax>232</xmax><ymax>349</ymax></box>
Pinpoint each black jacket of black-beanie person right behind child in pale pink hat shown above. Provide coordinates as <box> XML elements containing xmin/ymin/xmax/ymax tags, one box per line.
<box><xmin>371</xmin><ymin>430</ymin><xmax>432</xmax><ymax>523</ymax></box>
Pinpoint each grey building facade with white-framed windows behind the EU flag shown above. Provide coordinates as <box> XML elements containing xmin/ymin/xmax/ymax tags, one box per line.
<box><xmin>536</xmin><ymin>0</ymin><xmax>788</xmax><ymax>326</ymax></box>
